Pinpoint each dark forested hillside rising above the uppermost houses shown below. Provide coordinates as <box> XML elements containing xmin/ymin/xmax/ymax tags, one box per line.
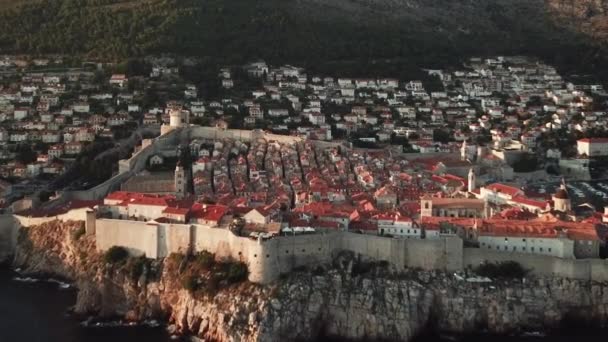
<box><xmin>0</xmin><ymin>0</ymin><xmax>608</xmax><ymax>77</ymax></box>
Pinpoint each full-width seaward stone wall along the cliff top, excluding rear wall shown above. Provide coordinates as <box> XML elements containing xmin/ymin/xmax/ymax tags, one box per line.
<box><xmin>0</xmin><ymin>208</ymin><xmax>608</xmax><ymax>284</ymax></box>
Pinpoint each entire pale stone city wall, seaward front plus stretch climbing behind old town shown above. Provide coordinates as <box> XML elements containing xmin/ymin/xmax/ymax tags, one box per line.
<box><xmin>0</xmin><ymin>125</ymin><xmax>608</xmax><ymax>284</ymax></box>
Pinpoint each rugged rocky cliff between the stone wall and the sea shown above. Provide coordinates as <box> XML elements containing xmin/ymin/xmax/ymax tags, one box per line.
<box><xmin>14</xmin><ymin>222</ymin><xmax>608</xmax><ymax>341</ymax></box>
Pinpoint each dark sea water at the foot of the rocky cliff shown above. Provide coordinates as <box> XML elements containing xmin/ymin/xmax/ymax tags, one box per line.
<box><xmin>0</xmin><ymin>269</ymin><xmax>608</xmax><ymax>342</ymax></box>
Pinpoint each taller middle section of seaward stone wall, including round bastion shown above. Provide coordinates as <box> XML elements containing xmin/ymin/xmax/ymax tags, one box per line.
<box><xmin>95</xmin><ymin>219</ymin><xmax>462</xmax><ymax>283</ymax></box>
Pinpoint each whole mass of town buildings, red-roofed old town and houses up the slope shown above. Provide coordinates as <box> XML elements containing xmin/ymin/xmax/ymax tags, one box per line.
<box><xmin>0</xmin><ymin>57</ymin><xmax>608</xmax><ymax>256</ymax></box>
